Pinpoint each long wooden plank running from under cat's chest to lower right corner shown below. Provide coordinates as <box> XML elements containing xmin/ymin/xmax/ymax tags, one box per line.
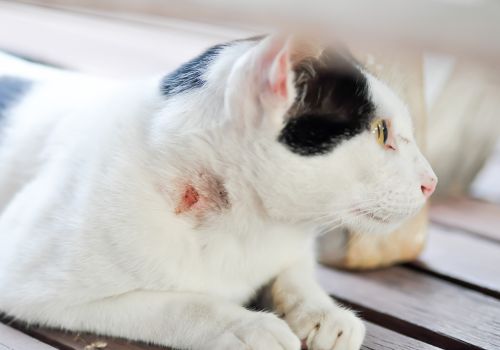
<box><xmin>318</xmin><ymin>267</ymin><xmax>500</xmax><ymax>349</ymax></box>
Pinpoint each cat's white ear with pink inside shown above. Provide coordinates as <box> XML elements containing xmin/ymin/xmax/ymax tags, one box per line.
<box><xmin>226</xmin><ymin>36</ymin><xmax>296</xmax><ymax>124</ymax></box>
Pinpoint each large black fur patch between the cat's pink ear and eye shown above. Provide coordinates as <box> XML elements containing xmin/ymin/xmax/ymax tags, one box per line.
<box><xmin>278</xmin><ymin>52</ymin><xmax>375</xmax><ymax>156</ymax></box>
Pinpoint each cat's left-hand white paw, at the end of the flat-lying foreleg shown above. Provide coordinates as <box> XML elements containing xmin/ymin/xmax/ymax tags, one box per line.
<box><xmin>207</xmin><ymin>313</ymin><xmax>300</xmax><ymax>350</ymax></box>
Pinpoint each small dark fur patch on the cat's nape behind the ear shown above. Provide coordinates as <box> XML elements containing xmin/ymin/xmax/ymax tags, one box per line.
<box><xmin>161</xmin><ymin>44</ymin><xmax>226</xmax><ymax>96</ymax></box>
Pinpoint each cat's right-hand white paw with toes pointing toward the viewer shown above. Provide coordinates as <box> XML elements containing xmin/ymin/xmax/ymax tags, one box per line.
<box><xmin>285</xmin><ymin>305</ymin><xmax>365</xmax><ymax>350</ymax></box>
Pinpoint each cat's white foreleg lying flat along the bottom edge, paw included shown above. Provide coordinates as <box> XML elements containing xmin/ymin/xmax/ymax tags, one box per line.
<box><xmin>28</xmin><ymin>291</ymin><xmax>300</xmax><ymax>350</ymax></box>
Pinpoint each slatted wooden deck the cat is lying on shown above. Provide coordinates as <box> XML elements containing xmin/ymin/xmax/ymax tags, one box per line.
<box><xmin>0</xmin><ymin>1</ymin><xmax>500</xmax><ymax>350</ymax></box>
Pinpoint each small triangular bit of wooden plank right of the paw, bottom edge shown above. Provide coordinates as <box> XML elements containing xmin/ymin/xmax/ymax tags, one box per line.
<box><xmin>362</xmin><ymin>322</ymin><xmax>438</xmax><ymax>350</ymax></box>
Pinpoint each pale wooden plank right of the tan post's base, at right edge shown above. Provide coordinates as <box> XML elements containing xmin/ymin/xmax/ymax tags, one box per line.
<box><xmin>413</xmin><ymin>224</ymin><xmax>500</xmax><ymax>299</ymax></box>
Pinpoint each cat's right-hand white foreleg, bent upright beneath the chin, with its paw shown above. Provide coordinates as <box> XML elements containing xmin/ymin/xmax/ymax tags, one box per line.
<box><xmin>269</xmin><ymin>259</ymin><xmax>365</xmax><ymax>350</ymax></box>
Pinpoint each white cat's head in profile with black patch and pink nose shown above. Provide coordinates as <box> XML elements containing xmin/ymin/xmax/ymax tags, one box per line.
<box><xmin>158</xmin><ymin>37</ymin><xmax>437</xmax><ymax>232</ymax></box>
